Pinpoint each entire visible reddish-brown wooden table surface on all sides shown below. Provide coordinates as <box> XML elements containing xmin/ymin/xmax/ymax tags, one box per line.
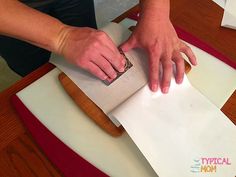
<box><xmin>0</xmin><ymin>0</ymin><xmax>236</xmax><ymax>177</ymax></box>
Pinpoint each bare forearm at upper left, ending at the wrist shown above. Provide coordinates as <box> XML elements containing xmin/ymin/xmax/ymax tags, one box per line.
<box><xmin>0</xmin><ymin>0</ymin><xmax>65</xmax><ymax>52</ymax></box>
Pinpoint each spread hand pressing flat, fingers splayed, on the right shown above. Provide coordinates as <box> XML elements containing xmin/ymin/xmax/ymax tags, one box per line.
<box><xmin>121</xmin><ymin>18</ymin><xmax>197</xmax><ymax>93</ymax></box>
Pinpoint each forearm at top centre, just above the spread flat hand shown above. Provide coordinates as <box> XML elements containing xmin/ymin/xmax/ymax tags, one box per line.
<box><xmin>140</xmin><ymin>0</ymin><xmax>170</xmax><ymax>22</ymax></box>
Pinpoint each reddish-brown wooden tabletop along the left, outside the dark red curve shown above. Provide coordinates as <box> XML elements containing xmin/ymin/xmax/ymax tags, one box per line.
<box><xmin>0</xmin><ymin>63</ymin><xmax>62</xmax><ymax>177</ymax></box>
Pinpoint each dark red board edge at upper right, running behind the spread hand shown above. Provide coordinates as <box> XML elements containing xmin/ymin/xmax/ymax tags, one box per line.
<box><xmin>129</xmin><ymin>13</ymin><xmax>236</xmax><ymax>69</ymax></box>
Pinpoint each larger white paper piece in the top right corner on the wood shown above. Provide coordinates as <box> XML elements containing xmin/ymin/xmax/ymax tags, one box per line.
<box><xmin>221</xmin><ymin>0</ymin><xmax>236</xmax><ymax>29</ymax></box>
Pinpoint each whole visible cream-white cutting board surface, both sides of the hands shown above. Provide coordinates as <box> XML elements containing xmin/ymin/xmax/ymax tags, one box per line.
<box><xmin>17</xmin><ymin>22</ymin><xmax>236</xmax><ymax>177</ymax></box>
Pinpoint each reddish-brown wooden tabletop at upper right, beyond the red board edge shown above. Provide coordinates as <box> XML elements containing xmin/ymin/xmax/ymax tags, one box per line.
<box><xmin>170</xmin><ymin>0</ymin><xmax>236</xmax><ymax>65</ymax></box>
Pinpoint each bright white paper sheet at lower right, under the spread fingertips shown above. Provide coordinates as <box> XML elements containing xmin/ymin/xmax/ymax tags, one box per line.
<box><xmin>112</xmin><ymin>75</ymin><xmax>236</xmax><ymax>177</ymax></box>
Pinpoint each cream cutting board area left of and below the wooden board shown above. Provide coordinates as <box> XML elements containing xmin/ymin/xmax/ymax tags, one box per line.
<box><xmin>17</xmin><ymin>69</ymin><xmax>156</xmax><ymax>177</ymax></box>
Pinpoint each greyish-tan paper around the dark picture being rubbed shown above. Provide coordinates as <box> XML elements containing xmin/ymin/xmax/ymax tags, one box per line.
<box><xmin>50</xmin><ymin>23</ymin><xmax>148</xmax><ymax>114</ymax></box>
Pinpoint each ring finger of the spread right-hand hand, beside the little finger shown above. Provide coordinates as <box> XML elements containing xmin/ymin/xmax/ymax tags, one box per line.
<box><xmin>172</xmin><ymin>52</ymin><xmax>185</xmax><ymax>84</ymax></box>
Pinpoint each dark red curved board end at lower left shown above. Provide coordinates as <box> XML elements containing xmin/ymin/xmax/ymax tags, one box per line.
<box><xmin>11</xmin><ymin>95</ymin><xmax>108</xmax><ymax>177</ymax></box>
